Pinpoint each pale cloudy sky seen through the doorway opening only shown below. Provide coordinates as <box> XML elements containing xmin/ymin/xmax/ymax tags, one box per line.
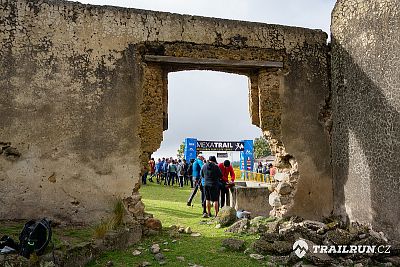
<box><xmin>152</xmin><ymin>71</ymin><xmax>262</xmax><ymax>162</ymax></box>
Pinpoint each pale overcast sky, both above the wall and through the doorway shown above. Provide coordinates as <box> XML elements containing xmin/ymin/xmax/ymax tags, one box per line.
<box><xmin>79</xmin><ymin>0</ymin><xmax>335</xmax><ymax>160</ymax></box>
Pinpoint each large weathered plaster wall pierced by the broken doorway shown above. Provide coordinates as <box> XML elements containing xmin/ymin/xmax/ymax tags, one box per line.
<box><xmin>0</xmin><ymin>0</ymin><xmax>333</xmax><ymax>222</ymax></box>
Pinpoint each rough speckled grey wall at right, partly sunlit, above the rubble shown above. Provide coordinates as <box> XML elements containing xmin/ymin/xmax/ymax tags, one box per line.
<box><xmin>331</xmin><ymin>0</ymin><xmax>400</xmax><ymax>239</ymax></box>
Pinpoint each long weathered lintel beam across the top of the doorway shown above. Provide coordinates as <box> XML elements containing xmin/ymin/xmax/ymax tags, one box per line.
<box><xmin>144</xmin><ymin>55</ymin><xmax>283</xmax><ymax>68</ymax></box>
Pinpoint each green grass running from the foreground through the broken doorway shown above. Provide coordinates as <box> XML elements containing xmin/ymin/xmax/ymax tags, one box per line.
<box><xmin>88</xmin><ymin>183</ymin><xmax>267</xmax><ymax>267</ymax></box>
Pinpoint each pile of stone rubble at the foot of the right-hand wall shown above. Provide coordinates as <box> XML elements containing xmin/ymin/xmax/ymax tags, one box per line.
<box><xmin>227</xmin><ymin>217</ymin><xmax>400</xmax><ymax>266</ymax></box>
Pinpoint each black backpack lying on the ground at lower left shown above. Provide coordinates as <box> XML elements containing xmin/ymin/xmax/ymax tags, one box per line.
<box><xmin>19</xmin><ymin>218</ymin><xmax>52</xmax><ymax>259</ymax></box>
